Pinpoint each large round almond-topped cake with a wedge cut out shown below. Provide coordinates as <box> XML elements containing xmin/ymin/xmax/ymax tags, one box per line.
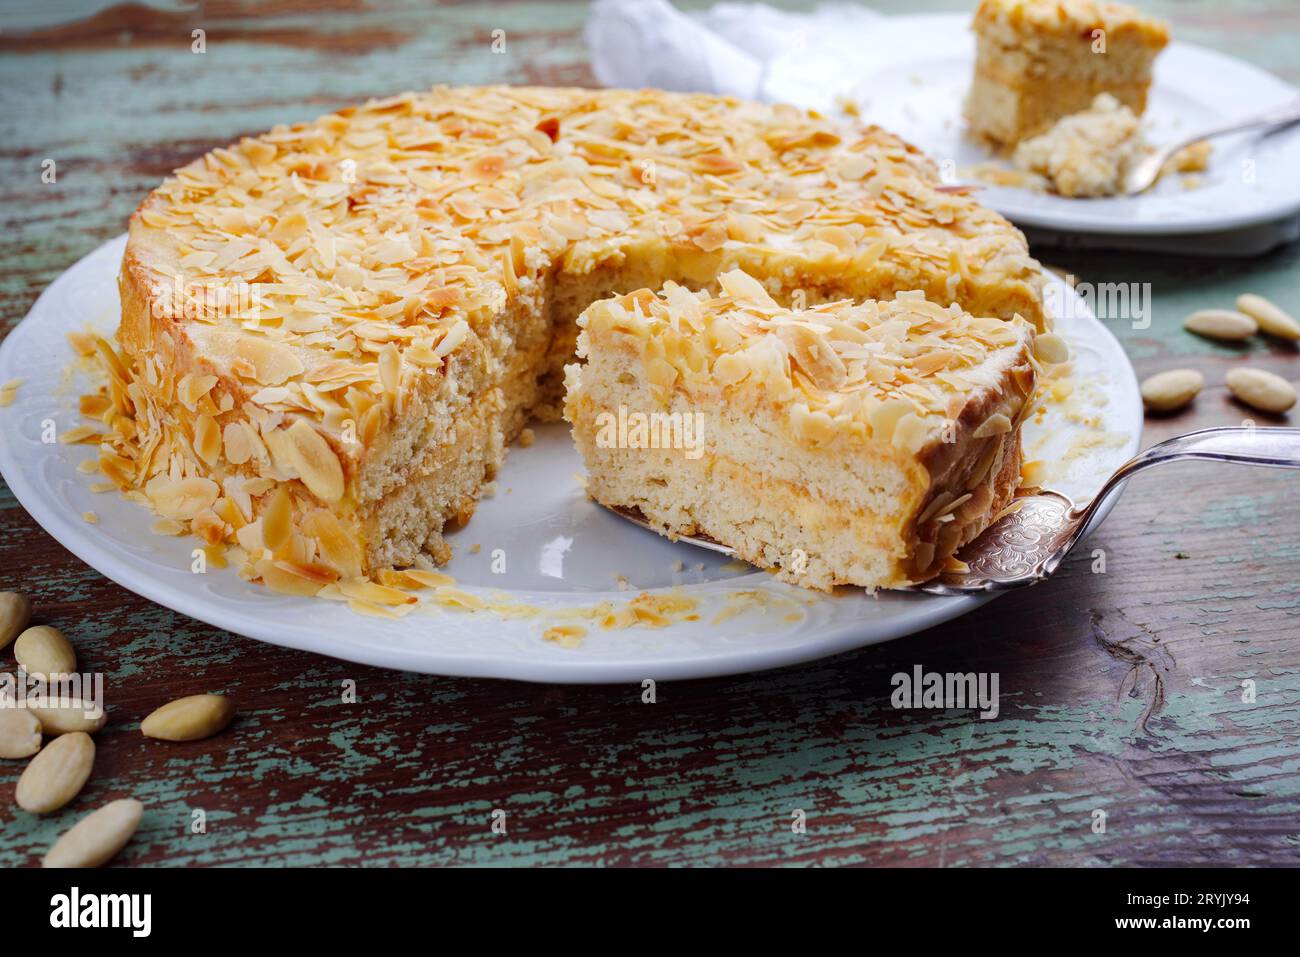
<box><xmin>83</xmin><ymin>87</ymin><xmax>1044</xmax><ymax>594</ymax></box>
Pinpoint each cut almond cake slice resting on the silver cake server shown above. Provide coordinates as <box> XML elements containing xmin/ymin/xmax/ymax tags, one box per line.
<box><xmin>566</xmin><ymin>270</ymin><xmax>1036</xmax><ymax>590</ymax></box>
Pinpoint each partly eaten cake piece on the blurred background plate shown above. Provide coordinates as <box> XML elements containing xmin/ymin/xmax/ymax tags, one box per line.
<box><xmin>965</xmin><ymin>0</ymin><xmax>1169</xmax><ymax>148</ymax></box>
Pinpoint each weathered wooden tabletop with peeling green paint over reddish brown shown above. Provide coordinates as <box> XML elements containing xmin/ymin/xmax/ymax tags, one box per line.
<box><xmin>0</xmin><ymin>0</ymin><xmax>1300</xmax><ymax>866</ymax></box>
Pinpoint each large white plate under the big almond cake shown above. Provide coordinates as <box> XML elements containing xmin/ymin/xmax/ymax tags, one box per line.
<box><xmin>0</xmin><ymin>237</ymin><xmax>1141</xmax><ymax>683</ymax></box>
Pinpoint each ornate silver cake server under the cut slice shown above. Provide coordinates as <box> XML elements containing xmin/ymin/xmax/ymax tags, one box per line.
<box><xmin>611</xmin><ymin>428</ymin><xmax>1300</xmax><ymax>594</ymax></box>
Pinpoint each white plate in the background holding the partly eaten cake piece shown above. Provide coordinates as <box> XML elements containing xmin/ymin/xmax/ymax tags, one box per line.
<box><xmin>763</xmin><ymin>14</ymin><xmax>1300</xmax><ymax>234</ymax></box>
